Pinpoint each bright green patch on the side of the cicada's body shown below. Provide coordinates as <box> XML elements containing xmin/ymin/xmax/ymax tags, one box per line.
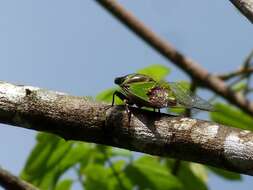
<box><xmin>128</xmin><ymin>81</ymin><xmax>157</xmax><ymax>102</ymax></box>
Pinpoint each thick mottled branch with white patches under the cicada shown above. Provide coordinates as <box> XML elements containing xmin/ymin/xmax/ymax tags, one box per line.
<box><xmin>0</xmin><ymin>82</ymin><xmax>253</xmax><ymax>175</ymax></box>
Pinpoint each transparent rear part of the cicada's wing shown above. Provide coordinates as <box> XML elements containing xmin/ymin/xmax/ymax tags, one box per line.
<box><xmin>169</xmin><ymin>82</ymin><xmax>213</xmax><ymax>111</ymax></box>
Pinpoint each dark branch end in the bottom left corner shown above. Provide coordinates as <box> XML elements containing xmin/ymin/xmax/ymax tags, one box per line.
<box><xmin>0</xmin><ymin>167</ymin><xmax>38</xmax><ymax>190</ymax></box>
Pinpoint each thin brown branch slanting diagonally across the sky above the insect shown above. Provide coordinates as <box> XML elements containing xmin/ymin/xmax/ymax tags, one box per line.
<box><xmin>96</xmin><ymin>0</ymin><xmax>253</xmax><ymax>115</ymax></box>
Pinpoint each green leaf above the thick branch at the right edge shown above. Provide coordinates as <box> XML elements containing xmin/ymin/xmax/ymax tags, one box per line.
<box><xmin>210</xmin><ymin>103</ymin><xmax>253</xmax><ymax>130</ymax></box>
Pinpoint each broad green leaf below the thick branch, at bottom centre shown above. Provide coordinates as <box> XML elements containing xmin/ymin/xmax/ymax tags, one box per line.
<box><xmin>125</xmin><ymin>156</ymin><xmax>182</xmax><ymax>189</ymax></box>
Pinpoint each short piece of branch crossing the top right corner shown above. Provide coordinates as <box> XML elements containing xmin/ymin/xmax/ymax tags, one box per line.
<box><xmin>230</xmin><ymin>0</ymin><xmax>253</xmax><ymax>23</ymax></box>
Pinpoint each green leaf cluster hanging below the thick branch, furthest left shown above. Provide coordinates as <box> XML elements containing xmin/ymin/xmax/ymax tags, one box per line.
<box><xmin>21</xmin><ymin>133</ymin><xmax>89</xmax><ymax>189</ymax></box>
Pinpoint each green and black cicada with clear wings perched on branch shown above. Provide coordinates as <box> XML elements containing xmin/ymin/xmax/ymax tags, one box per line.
<box><xmin>112</xmin><ymin>73</ymin><xmax>213</xmax><ymax>117</ymax></box>
